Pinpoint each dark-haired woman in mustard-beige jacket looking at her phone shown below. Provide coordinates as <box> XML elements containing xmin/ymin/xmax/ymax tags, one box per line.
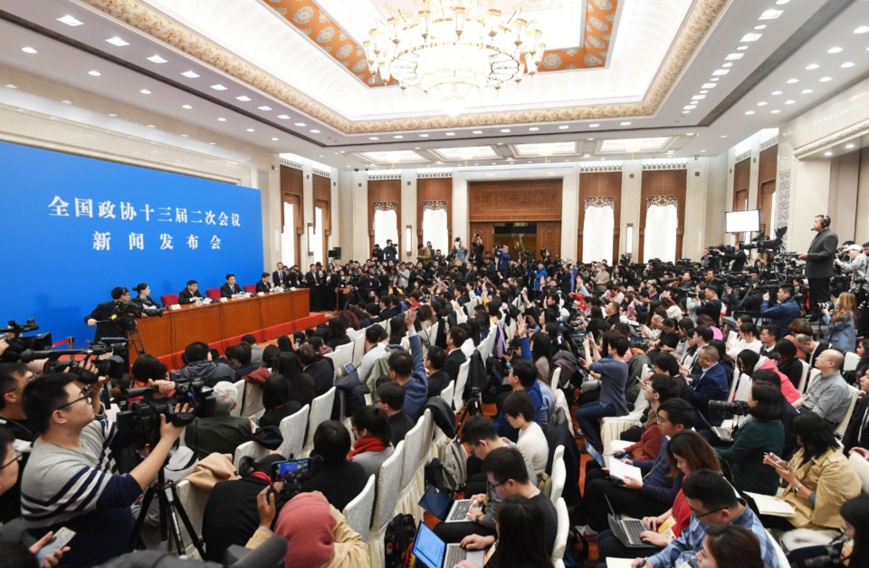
<box><xmin>761</xmin><ymin>412</ymin><xmax>863</xmax><ymax>531</ymax></box>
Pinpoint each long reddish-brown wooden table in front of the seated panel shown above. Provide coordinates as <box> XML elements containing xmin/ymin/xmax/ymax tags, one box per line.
<box><xmin>136</xmin><ymin>289</ymin><xmax>325</xmax><ymax>368</ymax></box>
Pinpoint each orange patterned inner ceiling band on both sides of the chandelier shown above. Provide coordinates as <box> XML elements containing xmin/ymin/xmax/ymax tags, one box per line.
<box><xmin>268</xmin><ymin>0</ymin><xmax>619</xmax><ymax>87</ymax></box>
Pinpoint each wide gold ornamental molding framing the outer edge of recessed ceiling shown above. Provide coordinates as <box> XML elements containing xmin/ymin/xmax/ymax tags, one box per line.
<box><xmin>82</xmin><ymin>0</ymin><xmax>730</xmax><ymax>135</ymax></box>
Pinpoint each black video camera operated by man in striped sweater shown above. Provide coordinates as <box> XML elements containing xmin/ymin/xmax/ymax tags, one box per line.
<box><xmin>117</xmin><ymin>380</ymin><xmax>217</xmax><ymax>439</ymax></box>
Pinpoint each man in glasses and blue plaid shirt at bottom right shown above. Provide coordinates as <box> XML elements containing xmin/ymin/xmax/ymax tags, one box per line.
<box><xmin>631</xmin><ymin>469</ymin><xmax>778</xmax><ymax>568</ymax></box>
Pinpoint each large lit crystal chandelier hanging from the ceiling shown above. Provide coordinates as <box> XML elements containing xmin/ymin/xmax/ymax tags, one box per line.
<box><xmin>364</xmin><ymin>0</ymin><xmax>546</xmax><ymax>117</ymax></box>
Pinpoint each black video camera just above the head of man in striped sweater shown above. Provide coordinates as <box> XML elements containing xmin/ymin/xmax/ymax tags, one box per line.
<box><xmin>21</xmin><ymin>337</ymin><xmax>128</xmax><ymax>384</ymax></box>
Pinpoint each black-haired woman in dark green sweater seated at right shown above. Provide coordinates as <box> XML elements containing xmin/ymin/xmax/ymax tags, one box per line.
<box><xmin>718</xmin><ymin>384</ymin><xmax>787</xmax><ymax>495</ymax></box>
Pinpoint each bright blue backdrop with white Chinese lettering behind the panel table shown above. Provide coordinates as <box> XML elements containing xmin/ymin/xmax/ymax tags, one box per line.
<box><xmin>0</xmin><ymin>143</ymin><xmax>263</xmax><ymax>347</ymax></box>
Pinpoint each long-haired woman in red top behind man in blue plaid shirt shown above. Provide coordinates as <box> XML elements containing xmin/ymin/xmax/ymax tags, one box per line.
<box><xmin>597</xmin><ymin>430</ymin><xmax>721</xmax><ymax>562</ymax></box>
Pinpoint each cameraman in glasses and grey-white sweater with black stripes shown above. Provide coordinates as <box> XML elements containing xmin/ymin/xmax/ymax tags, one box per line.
<box><xmin>21</xmin><ymin>373</ymin><xmax>187</xmax><ymax>566</ymax></box>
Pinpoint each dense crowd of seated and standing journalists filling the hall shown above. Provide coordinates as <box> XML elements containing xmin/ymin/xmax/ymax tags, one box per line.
<box><xmin>0</xmin><ymin>217</ymin><xmax>869</xmax><ymax>568</ymax></box>
